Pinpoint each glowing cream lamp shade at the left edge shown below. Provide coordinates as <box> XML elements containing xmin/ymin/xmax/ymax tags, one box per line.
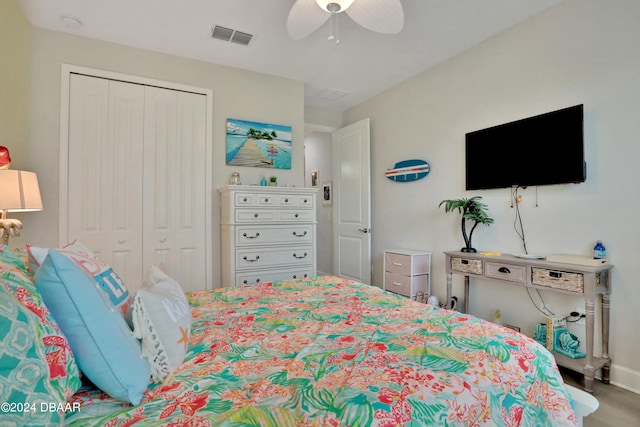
<box><xmin>0</xmin><ymin>169</ymin><xmax>42</xmax><ymax>212</ymax></box>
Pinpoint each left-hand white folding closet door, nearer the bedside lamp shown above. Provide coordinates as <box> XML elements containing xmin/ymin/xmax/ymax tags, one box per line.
<box><xmin>69</xmin><ymin>74</ymin><xmax>144</xmax><ymax>289</ymax></box>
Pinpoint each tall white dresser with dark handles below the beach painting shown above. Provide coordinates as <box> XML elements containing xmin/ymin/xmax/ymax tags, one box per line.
<box><xmin>218</xmin><ymin>185</ymin><xmax>318</xmax><ymax>286</ymax></box>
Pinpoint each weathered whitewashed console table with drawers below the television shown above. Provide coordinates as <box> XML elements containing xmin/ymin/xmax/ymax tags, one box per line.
<box><xmin>445</xmin><ymin>252</ymin><xmax>613</xmax><ymax>393</ymax></box>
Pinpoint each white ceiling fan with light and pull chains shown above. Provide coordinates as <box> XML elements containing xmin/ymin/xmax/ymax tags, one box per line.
<box><xmin>287</xmin><ymin>0</ymin><xmax>404</xmax><ymax>40</ymax></box>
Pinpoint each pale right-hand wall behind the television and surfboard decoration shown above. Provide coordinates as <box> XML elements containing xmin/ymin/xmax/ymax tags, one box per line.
<box><xmin>344</xmin><ymin>0</ymin><xmax>640</xmax><ymax>392</ymax></box>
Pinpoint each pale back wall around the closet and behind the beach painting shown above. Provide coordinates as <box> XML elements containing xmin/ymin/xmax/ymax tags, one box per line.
<box><xmin>21</xmin><ymin>28</ymin><xmax>304</xmax><ymax>287</ymax></box>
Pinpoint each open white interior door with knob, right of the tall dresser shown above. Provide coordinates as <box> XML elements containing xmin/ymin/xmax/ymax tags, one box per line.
<box><xmin>332</xmin><ymin>119</ymin><xmax>371</xmax><ymax>284</ymax></box>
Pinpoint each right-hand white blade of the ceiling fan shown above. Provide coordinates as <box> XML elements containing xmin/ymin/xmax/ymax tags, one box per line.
<box><xmin>346</xmin><ymin>0</ymin><xmax>404</xmax><ymax>34</ymax></box>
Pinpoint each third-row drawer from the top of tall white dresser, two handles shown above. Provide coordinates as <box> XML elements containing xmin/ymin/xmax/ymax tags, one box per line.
<box><xmin>236</xmin><ymin>224</ymin><xmax>313</xmax><ymax>246</ymax></box>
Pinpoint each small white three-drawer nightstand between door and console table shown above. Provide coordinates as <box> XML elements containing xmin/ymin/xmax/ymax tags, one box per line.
<box><xmin>382</xmin><ymin>249</ymin><xmax>431</xmax><ymax>298</ymax></box>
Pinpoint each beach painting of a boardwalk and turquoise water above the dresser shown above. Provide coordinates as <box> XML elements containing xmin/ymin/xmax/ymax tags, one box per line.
<box><xmin>227</xmin><ymin>119</ymin><xmax>291</xmax><ymax>169</ymax></box>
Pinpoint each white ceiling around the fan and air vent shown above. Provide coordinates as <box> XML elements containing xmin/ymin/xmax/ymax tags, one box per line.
<box><xmin>18</xmin><ymin>0</ymin><xmax>561</xmax><ymax>111</ymax></box>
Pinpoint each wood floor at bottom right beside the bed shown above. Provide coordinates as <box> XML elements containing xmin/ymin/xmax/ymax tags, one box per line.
<box><xmin>561</xmin><ymin>369</ymin><xmax>640</xmax><ymax>427</ymax></box>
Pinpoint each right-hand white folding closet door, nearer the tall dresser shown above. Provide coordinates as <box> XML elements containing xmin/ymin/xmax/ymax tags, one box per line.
<box><xmin>143</xmin><ymin>87</ymin><xmax>206</xmax><ymax>291</ymax></box>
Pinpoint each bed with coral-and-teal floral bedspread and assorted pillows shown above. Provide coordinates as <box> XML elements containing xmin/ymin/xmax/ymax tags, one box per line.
<box><xmin>0</xmin><ymin>242</ymin><xmax>579</xmax><ymax>427</ymax></box>
